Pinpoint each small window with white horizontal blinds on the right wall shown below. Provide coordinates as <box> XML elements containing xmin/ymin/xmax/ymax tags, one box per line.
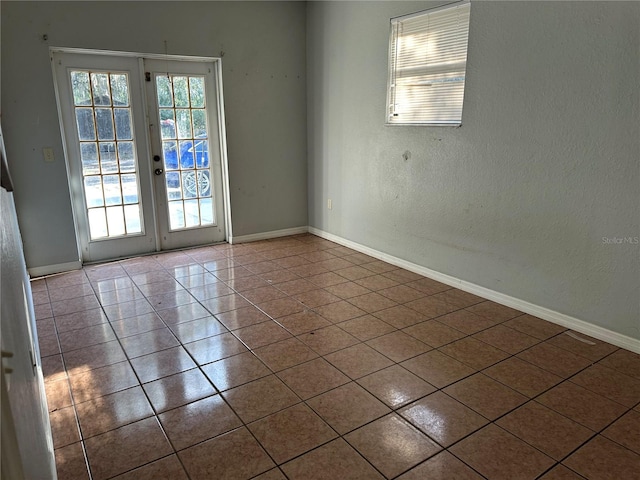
<box><xmin>387</xmin><ymin>2</ymin><xmax>470</xmax><ymax>126</ymax></box>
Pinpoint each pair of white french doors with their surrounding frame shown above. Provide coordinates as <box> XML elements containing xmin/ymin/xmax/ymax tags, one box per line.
<box><xmin>52</xmin><ymin>50</ymin><xmax>228</xmax><ymax>262</ymax></box>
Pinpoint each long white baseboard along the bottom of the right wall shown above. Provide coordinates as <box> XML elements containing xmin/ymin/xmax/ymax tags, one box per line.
<box><xmin>308</xmin><ymin>227</ymin><xmax>640</xmax><ymax>353</ymax></box>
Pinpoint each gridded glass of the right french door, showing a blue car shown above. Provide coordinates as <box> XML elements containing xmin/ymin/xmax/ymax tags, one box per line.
<box><xmin>155</xmin><ymin>74</ymin><xmax>216</xmax><ymax>231</ymax></box>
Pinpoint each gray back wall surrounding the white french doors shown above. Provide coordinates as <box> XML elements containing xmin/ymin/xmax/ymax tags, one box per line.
<box><xmin>1</xmin><ymin>1</ymin><xmax>307</xmax><ymax>268</ymax></box>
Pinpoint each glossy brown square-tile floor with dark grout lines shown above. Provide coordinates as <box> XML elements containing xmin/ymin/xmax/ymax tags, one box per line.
<box><xmin>32</xmin><ymin>235</ymin><xmax>640</xmax><ymax>480</ymax></box>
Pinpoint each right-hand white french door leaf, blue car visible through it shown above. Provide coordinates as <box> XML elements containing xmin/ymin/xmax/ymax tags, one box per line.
<box><xmin>144</xmin><ymin>59</ymin><xmax>225</xmax><ymax>249</ymax></box>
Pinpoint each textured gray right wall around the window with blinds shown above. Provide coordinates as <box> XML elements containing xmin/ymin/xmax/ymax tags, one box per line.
<box><xmin>307</xmin><ymin>1</ymin><xmax>640</xmax><ymax>339</ymax></box>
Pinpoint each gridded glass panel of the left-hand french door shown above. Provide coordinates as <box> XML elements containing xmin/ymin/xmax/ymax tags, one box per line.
<box><xmin>70</xmin><ymin>70</ymin><xmax>144</xmax><ymax>240</ymax></box>
